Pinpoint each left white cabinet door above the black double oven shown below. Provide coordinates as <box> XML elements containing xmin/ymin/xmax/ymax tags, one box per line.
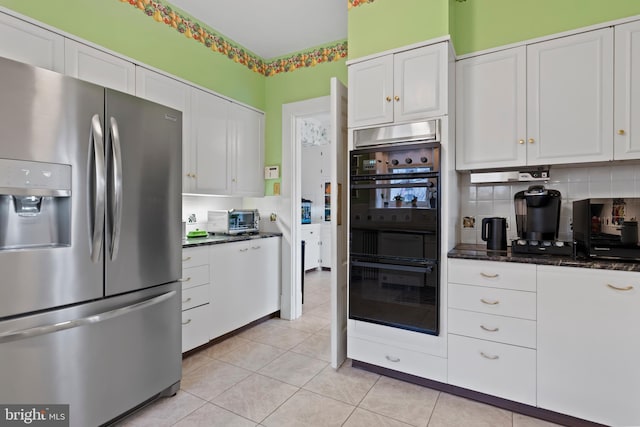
<box><xmin>348</xmin><ymin>55</ymin><xmax>394</xmax><ymax>127</ymax></box>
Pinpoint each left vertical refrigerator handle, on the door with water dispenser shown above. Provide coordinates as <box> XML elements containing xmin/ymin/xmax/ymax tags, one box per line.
<box><xmin>87</xmin><ymin>114</ymin><xmax>106</xmax><ymax>263</ymax></box>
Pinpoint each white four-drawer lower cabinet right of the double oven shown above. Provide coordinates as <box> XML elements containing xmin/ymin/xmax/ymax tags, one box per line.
<box><xmin>448</xmin><ymin>259</ymin><xmax>537</xmax><ymax>406</ymax></box>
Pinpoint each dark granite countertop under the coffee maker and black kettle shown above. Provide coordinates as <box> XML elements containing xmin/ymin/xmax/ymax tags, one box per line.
<box><xmin>447</xmin><ymin>244</ymin><xmax>640</xmax><ymax>271</ymax></box>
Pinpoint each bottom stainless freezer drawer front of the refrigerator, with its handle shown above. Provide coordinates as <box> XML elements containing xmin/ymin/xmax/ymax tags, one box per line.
<box><xmin>0</xmin><ymin>282</ymin><xmax>182</xmax><ymax>427</ymax></box>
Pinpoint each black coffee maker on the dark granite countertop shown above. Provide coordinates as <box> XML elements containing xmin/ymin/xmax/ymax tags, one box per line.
<box><xmin>514</xmin><ymin>185</ymin><xmax>562</xmax><ymax>241</ymax></box>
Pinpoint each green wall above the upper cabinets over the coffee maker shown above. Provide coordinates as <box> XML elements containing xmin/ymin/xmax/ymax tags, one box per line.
<box><xmin>451</xmin><ymin>0</ymin><xmax>640</xmax><ymax>55</ymax></box>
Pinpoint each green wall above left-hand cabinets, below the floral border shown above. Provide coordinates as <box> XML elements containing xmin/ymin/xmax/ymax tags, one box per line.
<box><xmin>0</xmin><ymin>0</ymin><xmax>266</xmax><ymax>110</ymax></box>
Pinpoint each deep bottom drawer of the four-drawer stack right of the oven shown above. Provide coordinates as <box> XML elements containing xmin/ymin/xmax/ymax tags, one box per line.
<box><xmin>449</xmin><ymin>335</ymin><xmax>536</xmax><ymax>406</ymax></box>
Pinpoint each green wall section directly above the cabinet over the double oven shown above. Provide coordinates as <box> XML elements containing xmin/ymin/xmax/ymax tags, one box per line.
<box><xmin>345</xmin><ymin>0</ymin><xmax>448</xmax><ymax>59</ymax></box>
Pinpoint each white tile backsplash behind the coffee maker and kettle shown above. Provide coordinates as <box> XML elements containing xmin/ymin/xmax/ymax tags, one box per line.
<box><xmin>458</xmin><ymin>163</ymin><xmax>640</xmax><ymax>244</ymax></box>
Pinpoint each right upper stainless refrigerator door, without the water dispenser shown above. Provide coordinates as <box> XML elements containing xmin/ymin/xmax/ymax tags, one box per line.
<box><xmin>105</xmin><ymin>90</ymin><xmax>182</xmax><ymax>296</ymax></box>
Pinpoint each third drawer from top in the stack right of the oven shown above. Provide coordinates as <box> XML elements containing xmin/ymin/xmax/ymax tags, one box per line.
<box><xmin>448</xmin><ymin>308</ymin><xmax>536</xmax><ymax>348</ymax></box>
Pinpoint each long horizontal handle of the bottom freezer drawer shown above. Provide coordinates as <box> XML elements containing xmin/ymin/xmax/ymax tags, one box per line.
<box><xmin>0</xmin><ymin>291</ymin><xmax>176</xmax><ymax>344</ymax></box>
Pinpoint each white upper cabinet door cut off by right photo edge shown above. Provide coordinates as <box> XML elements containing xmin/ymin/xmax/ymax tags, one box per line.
<box><xmin>613</xmin><ymin>21</ymin><xmax>640</xmax><ymax>160</ymax></box>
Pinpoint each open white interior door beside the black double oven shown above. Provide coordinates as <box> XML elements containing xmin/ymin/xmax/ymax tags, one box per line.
<box><xmin>330</xmin><ymin>77</ymin><xmax>349</xmax><ymax>369</ymax></box>
